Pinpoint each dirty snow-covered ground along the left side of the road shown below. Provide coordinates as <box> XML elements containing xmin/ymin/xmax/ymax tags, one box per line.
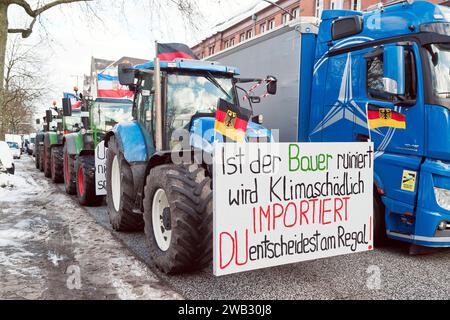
<box><xmin>0</xmin><ymin>157</ymin><xmax>182</xmax><ymax>299</ymax></box>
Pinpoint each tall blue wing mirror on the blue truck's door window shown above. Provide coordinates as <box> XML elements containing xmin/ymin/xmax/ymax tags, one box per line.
<box><xmin>383</xmin><ymin>44</ymin><xmax>406</xmax><ymax>96</ymax></box>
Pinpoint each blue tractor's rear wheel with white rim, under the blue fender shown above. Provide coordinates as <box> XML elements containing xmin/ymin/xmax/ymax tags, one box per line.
<box><xmin>106</xmin><ymin>137</ymin><xmax>144</xmax><ymax>232</ymax></box>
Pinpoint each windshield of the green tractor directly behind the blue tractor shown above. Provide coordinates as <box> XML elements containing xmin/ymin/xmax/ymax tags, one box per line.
<box><xmin>92</xmin><ymin>102</ymin><xmax>133</xmax><ymax>131</ymax></box>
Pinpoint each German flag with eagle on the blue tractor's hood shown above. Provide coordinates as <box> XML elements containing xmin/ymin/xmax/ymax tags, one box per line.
<box><xmin>214</xmin><ymin>99</ymin><xmax>251</xmax><ymax>142</ymax></box>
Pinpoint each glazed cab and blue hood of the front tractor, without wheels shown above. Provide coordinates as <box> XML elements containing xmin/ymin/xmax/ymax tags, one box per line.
<box><xmin>119</xmin><ymin>59</ymin><xmax>276</xmax><ymax>156</ymax></box>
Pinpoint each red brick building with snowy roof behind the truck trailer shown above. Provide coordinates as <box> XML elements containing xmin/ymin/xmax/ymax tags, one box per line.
<box><xmin>192</xmin><ymin>0</ymin><xmax>450</xmax><ymax>59</ymax></box>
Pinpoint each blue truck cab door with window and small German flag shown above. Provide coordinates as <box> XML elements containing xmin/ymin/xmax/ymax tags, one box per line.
<box><xmin>354</xmin><ymin>42</ymin><xmax>425</xmax><ymax>212</ymax></box>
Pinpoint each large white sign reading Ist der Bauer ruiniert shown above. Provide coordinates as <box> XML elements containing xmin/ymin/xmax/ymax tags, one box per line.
<box><xmin>213</xmin><ymin>143</ymin><xmax>374</xmax><ymax>276</ymax></box>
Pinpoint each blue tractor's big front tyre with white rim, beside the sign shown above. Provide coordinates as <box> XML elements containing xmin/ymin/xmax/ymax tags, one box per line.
<box><xmin>144</xmin><ymin>165</ymin><xmax>213</xmax><ymax>274</ymax></box>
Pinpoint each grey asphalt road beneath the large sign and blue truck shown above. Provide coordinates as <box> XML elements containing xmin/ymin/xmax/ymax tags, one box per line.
<box><xmin>48</xmin><ymin>158</ymin><xmax>450</xmax><ymax>300</ymax></box>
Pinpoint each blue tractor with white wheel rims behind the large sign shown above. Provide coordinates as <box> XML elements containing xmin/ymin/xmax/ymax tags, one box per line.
<box><xmin>105</xmin><ymin>59</ymin><xmax>277</xmax><ymax>273</ymax></box>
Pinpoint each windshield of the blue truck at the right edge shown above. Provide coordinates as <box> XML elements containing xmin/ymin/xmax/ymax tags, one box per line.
<box><xmin>426</xmin><ymin>44</ymin><xmax>450</xmax><ymax>99</ymax></box>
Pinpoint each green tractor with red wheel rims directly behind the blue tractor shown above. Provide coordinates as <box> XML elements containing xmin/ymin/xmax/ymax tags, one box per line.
<box><xmin>61</xmin><ymin>95</ymin><xmax>133</xmax><ymax>206</ymax></box>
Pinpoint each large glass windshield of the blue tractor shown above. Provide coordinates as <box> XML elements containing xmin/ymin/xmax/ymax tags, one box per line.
<box><xmin>167</xmin><ymin>73</ymin><xmax>235</xmax><ymax>137</ymax></box>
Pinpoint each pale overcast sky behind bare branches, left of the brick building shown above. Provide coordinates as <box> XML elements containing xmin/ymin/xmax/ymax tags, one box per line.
<box><xmin>9</xmin><ymin>0</ymin><xmax>259</xmax><ymax>115</ymax></box>
